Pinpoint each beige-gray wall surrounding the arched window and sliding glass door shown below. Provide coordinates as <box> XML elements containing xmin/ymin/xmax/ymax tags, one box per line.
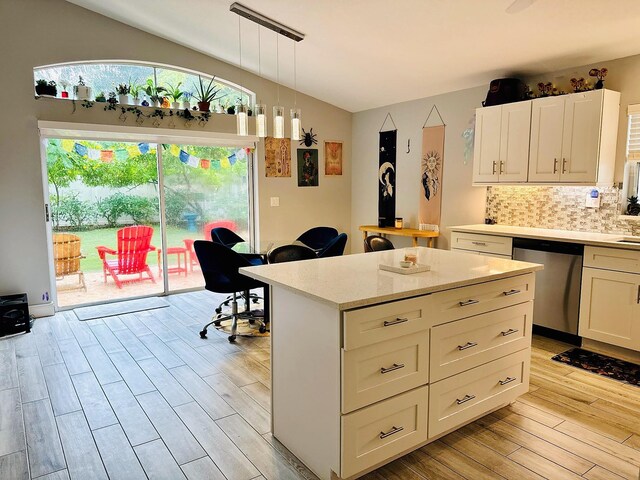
<box><xmin>0</xmin><ymin>0</ymin><xmax>352</xmax><ymax>304</ymax></box>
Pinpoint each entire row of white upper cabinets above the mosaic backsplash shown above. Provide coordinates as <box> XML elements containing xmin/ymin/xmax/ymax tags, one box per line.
<box><xmin>473</xmin><ymin>90</ymin><xmax>620</xmax><ymax>185</ymax></box>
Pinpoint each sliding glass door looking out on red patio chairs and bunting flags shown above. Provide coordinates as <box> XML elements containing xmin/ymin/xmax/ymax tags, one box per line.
<box><xmin>46</xmin><ymin>139</ymin><xmax>252</xmax><ymax>308</ymax></box>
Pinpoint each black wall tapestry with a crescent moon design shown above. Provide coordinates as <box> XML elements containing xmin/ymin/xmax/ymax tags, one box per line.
<box><xmin>378</xmin><ymin>113</ymin><xmax>398</xmax><ymax>227</ymax></box>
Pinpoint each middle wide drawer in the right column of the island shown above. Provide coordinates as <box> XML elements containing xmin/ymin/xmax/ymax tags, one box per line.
<box><xmin>429</xmin><ymin>302</ymin><xmax>533</xmax><ymax>383</ymax></box>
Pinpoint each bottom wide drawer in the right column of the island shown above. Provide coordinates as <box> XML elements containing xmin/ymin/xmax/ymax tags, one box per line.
<box><xmin>429</xmin><ymin>348</ymin><xmax>531</xmax><ymax>438</ymax></box>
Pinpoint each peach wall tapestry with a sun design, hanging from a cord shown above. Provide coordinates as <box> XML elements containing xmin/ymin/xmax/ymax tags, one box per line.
<box><xmin>418</xmin><ymin>105</ymin><xmax>445</xmax><ymax>225</ymax></box>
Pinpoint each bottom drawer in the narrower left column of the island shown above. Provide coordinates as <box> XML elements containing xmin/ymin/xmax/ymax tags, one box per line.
<box><xmin>340</xmin><ymin>386</ymin><xmax>429</xmax><ymax>478</ymax></box>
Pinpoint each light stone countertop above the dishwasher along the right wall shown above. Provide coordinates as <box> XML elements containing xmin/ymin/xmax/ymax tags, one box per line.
<box><xmin>449</xmin><ymin>224</ymin><xmax>640</xmax><ymax>250</ymax></box>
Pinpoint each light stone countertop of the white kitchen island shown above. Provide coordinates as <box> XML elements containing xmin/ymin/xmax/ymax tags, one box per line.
<box><xmin>240</xmin><ymin>247</ymin><xmax>542</xmax><ymax>310</ymax></box>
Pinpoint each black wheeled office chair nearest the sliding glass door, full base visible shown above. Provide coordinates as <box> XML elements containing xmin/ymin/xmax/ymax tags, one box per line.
<box><xmin>193</xmin><ymin>240</ymin><xmax>269</xmax><ymax>342</ymax></box>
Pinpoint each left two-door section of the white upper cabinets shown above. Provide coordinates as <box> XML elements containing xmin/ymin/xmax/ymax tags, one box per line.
<box><xmin>473</xmin><ymin>101</ymin><xmax>532</xmax><ymax>183</ymax></box>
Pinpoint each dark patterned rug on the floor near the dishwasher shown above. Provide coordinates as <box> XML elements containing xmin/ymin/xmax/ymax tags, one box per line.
<box><xmin>551</xmin><ymin>348</ymin><xmax>640</xmax><ymax>386</ymax></box>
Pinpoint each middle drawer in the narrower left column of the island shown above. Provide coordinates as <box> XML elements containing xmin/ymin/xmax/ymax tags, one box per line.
<box><xmin>342</xmin><ymin>330</ymin><xmax>429</xmax><ymax>413</ymax></box>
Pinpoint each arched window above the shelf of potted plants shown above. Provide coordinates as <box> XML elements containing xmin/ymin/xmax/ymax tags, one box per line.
<box><xmin>33</xmin><ymin>61</ymin><xmax>255</xmax><ymax>106</ymax></box>
